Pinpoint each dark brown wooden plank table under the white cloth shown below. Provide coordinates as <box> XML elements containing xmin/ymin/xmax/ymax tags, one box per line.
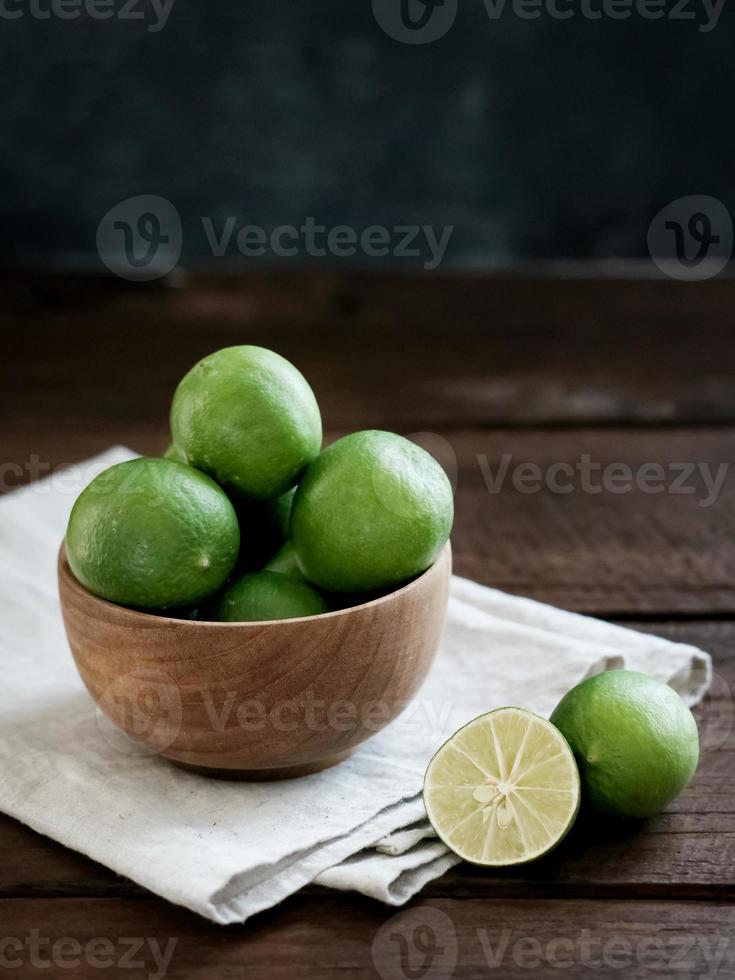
<box><xmin>0</xmin><ymin>274</ymin><xmax>735</xmax><ymax>980</ymax></box>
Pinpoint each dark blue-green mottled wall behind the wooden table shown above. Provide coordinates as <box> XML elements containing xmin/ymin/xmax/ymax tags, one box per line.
<box><xmin>0</xmin><ymin>0</ymin><xmax>735</xmax><ymax>268</ymax></box>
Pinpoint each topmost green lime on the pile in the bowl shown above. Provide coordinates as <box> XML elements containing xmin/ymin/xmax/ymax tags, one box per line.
<box><xmin>171</xmin><ymin>346</ymin><xmax>322</xmax><ymax>500</ymax></box>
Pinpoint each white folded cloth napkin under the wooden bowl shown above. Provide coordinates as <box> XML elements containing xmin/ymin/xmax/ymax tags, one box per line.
<box><xmin>0</xmin><ymin>448</ymin><xmax>711</xmax><ymax>923</ymax></box>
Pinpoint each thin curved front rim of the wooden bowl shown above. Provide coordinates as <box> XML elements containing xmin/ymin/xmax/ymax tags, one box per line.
<box><xmin>57</xmin><ymin>538</ymin><xmax>452</xmax><ymax>629</ymax></box>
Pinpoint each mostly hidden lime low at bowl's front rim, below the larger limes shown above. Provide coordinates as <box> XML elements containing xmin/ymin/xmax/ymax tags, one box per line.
<box><xmin>207</xmin><ymin>572</ymin><xmax>328</xmax><ymax>623</ymax></box>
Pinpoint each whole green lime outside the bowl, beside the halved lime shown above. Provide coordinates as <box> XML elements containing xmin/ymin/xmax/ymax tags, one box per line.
<box><xmin>551</xmin><ymin>670</ymin><xmax>699</xmax><ymax>817</ymax></box>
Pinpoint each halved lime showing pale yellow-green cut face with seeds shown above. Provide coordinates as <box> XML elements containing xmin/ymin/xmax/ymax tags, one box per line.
<box><xmin>424</xmin><ymin>708</ymin><xmax>580</xmax><ymax>867</ymax></box>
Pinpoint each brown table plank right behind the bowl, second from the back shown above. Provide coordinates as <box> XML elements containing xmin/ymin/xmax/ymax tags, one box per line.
<box><xmin>4</xmin><ymin>419</ymin><xmax>735</xmax><ymax>617</ymax></box>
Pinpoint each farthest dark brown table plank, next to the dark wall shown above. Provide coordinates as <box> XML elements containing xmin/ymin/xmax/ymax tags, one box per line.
<box><xmin>0</xmin><ymin>275</ymin><xmax>735</xmax><ymax>431</ymax></box>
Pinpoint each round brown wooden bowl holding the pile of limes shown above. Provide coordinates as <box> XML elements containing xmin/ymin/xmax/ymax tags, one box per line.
<box><xmin>58</xmin><ymin>544</ymin><xmax>452</xmax><ymax>779</ymax></box>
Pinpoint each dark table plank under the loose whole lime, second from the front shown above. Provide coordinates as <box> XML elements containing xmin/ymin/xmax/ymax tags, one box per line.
<box><xmin>0</xmin><ymin>622</ymin><xmax>735</xmax><ymax>914</ymax></box>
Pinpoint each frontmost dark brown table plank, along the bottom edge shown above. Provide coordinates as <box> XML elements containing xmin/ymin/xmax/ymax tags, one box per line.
<box><xmin>0</xmin><ymin>896</ymin><xmax>735</xmax><ymax>980</ymax></box>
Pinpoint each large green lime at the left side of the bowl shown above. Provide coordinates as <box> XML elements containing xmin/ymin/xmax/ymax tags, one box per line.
<box><xmin>66</xmin><ymin>459</ymin><xmax>240</xmax><ymax>609</ymax></box>
